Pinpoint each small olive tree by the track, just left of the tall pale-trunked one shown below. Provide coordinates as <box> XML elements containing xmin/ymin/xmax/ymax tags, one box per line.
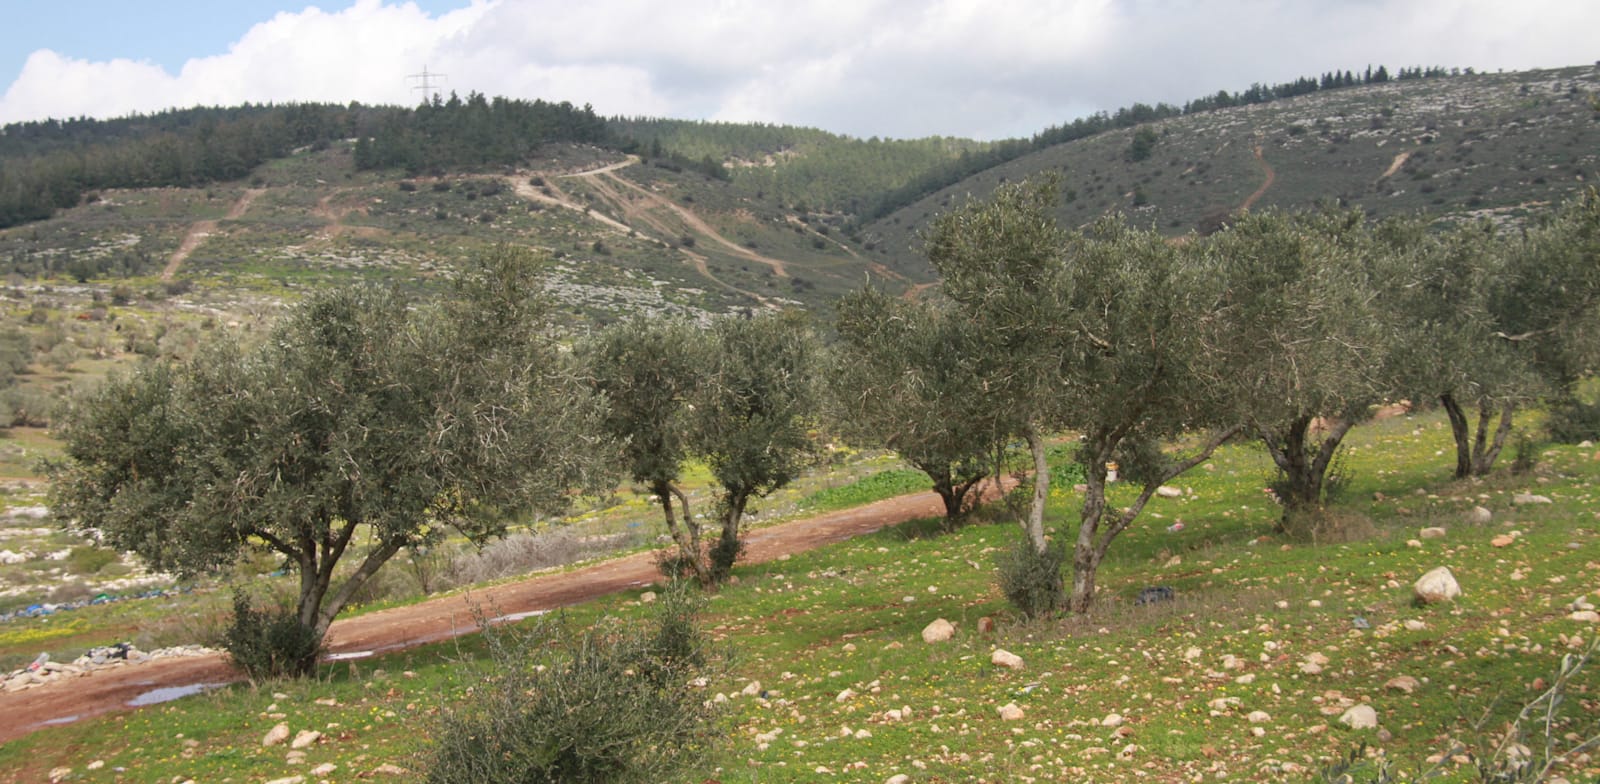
<box><xmin>829</xmin><ymin>288</ymin><xmax>1014</xmax><ymax>526</ymax></box>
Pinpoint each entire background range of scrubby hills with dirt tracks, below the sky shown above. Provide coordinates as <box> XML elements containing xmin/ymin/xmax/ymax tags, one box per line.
<box><xmin>0</xmin><ymin>66</ymin><xmax>1600</xmax><ymax>386</ymax></box>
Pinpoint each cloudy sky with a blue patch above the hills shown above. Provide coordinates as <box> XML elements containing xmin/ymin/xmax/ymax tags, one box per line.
<box><xmin>0</xmin><ymin>0</ymin><xmax>1600</xmax><ymax>139</ymax></box>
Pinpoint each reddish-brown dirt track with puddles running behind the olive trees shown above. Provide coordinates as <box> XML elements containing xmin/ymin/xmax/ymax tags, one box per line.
<box><xmin>0</xmin><ymin>480</ymin><xmax>1014</xmax><ymax>742</ymax></box>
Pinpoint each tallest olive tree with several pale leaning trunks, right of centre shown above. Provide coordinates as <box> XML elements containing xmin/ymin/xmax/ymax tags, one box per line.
<box><xmin>930</xmin><ymin>179</ymin><xmax>1237</xmax><ymax>613</ymax></box>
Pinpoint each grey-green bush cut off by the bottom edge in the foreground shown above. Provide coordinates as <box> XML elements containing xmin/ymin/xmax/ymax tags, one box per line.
<box><xmin>426</xmin><ymin>587</ymin><xmax>718</xmax><ymax>784</ymax></box>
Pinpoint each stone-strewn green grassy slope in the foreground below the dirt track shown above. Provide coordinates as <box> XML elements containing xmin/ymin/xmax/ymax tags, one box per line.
<box><xmin>0</xmin><ymin>416</ymin><xmax>1600</xmax><ymax>782</ymax></box>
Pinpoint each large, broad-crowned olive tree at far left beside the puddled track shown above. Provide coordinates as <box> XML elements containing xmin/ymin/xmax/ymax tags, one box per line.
<box><xmin>51</xmin><ymin>248</ymin><xmax>603</xmax><ymax>675</ymax></box>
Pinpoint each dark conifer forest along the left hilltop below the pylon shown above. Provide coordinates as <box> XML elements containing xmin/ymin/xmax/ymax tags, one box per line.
<box><xmin>0</xmin><ymin>93</ymin><xmax>608</xmax><ymax>227</ymax></box>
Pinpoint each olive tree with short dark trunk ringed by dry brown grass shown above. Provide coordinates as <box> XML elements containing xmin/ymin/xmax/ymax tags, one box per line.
<box><xmin>1208</xmin><ymin>211</ymin><xmax>1398</xmax><ymax>533</ymax></box>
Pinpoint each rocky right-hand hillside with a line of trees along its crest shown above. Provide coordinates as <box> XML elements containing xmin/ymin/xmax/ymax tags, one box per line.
<box><xmin>861</xmin><ymin>66</ymin><xmax>1600</xmax><ymax>277</ymax></box>
